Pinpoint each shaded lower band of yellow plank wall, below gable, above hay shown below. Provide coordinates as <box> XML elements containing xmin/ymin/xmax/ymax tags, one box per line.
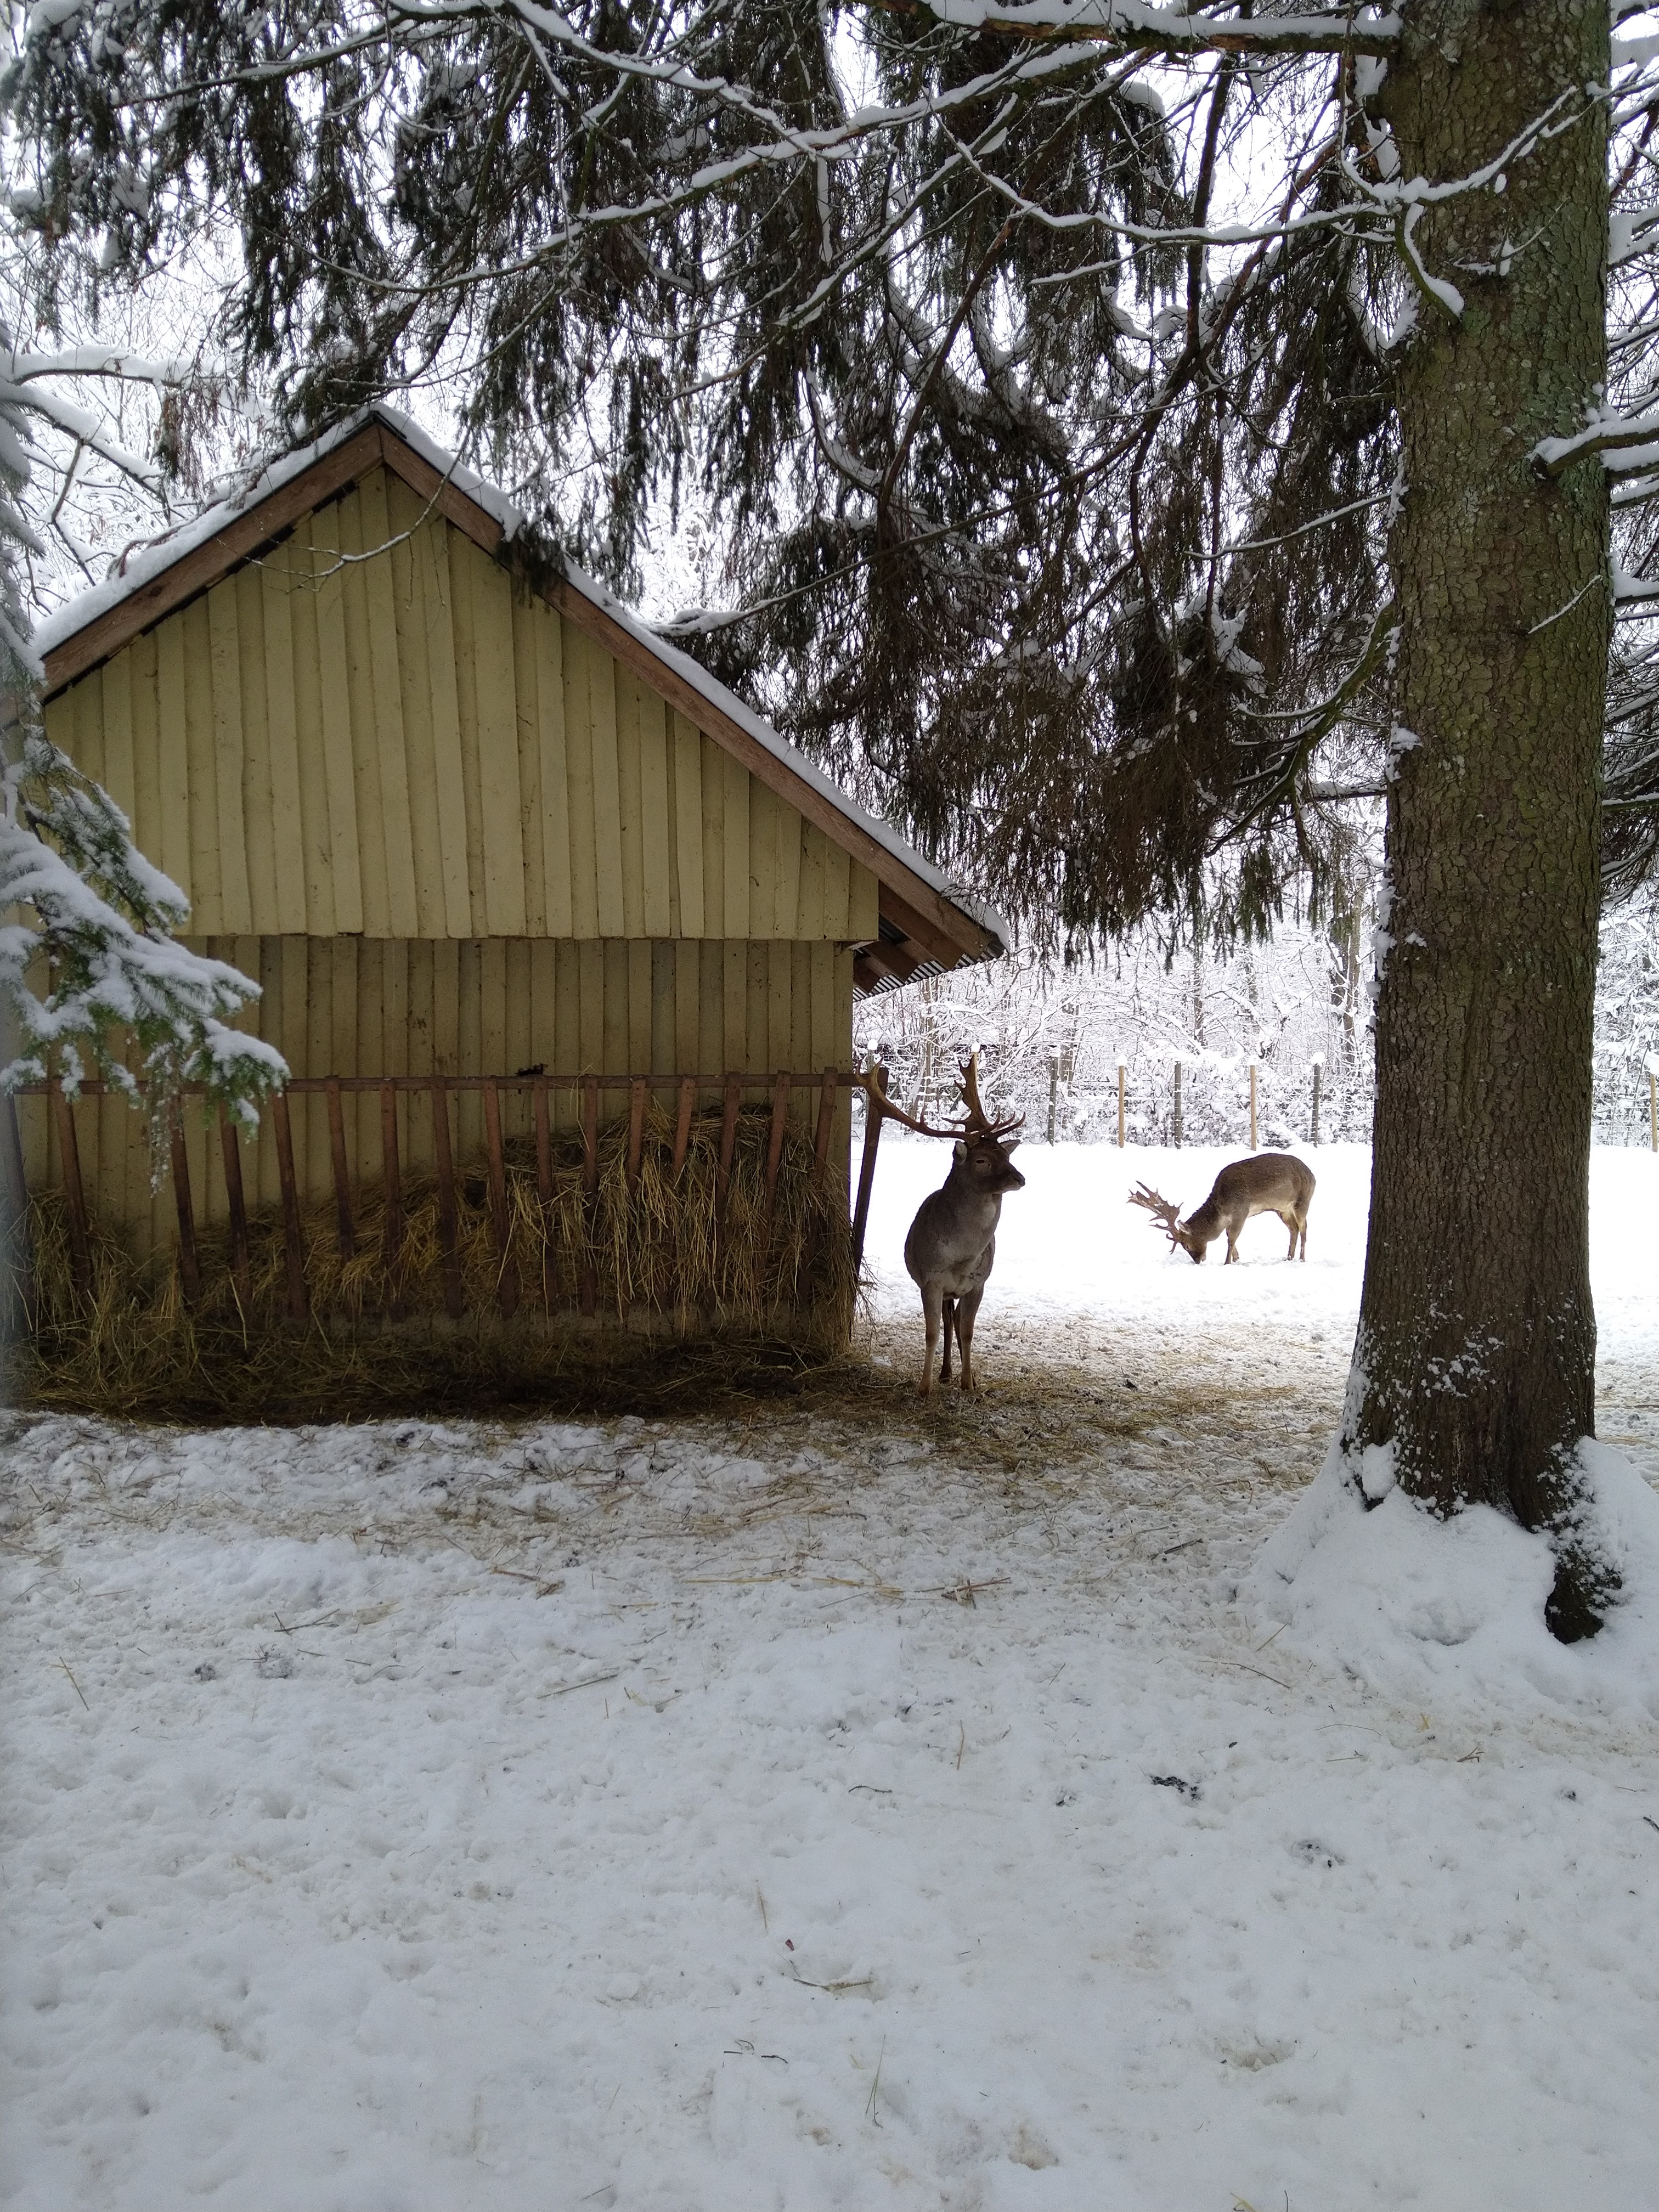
<box><xmin>18</xmin><ymin>936</ymin><xmax>851</xmax><ymax>1256</ymax></box>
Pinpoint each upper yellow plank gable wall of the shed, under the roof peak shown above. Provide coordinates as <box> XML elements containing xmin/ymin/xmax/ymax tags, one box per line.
<box><xmin>47</xmin><ymin>469</ymin><xmax>878</xmax><ymax>945</ymax></box>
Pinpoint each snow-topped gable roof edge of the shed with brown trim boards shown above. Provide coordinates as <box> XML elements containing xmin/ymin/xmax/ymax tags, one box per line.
<box><xmin>36</xmin><ymin>405</ymin><xmax>1009</xmax><ymax>991</ymax></box>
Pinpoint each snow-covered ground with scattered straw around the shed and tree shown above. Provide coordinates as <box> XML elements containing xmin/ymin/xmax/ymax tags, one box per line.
<box><xmin>0</xmin><ymin>1137</ymin><xmax>1659</xmax><ymax>2212</ymax></box>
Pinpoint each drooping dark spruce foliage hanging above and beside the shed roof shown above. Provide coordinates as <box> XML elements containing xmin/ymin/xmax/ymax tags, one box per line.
<box><xmin>4</xmin><ymin>0</ymin><xmax>1659</xmax><ymax>945</ymax></box>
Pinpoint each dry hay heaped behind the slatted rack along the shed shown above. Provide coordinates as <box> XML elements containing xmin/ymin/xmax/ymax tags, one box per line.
<box><xmin>4</xmin><ymin>1106</ymin><xmax>856</xmax><ymax>1420</ymax></box>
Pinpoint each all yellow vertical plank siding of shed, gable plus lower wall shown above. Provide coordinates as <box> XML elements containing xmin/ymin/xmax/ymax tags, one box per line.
<box><xmin>36</xmin><ymin>469</ymin><xmax>878</xmax><ymax>1252</ymax></box>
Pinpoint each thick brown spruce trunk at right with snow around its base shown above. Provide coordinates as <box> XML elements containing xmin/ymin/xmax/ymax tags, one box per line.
<box><xmin>1345</xmin><ymin>0</ymin><xmax>1617</xmax><ymax>1641</ymax></box>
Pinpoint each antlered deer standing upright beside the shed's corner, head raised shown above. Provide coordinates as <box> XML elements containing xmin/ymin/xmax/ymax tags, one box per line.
<box><xmin>872</xmin><ymin>1053</ymin><xmax>1026</xmax><ymax>1396</ymax></box>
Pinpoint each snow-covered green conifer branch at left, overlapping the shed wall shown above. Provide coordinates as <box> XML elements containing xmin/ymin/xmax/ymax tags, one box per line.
<box><xmin>0</xmin><ymin>728</ymin><xmax>287</xmax><ymax>1124</ymax></box>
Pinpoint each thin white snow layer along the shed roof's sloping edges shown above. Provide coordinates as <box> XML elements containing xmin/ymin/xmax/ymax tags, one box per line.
<box><xmin>33</xmin><ymin>400</ymin><xmax>1013</xmax><ymax>949</ymax></box>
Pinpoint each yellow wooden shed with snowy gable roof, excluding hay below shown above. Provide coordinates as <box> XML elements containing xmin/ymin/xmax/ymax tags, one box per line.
<box><xmin>13</xmin><ymin>409</ymin><xmax>1002</xmax><ymax>1353</ymax></box>
